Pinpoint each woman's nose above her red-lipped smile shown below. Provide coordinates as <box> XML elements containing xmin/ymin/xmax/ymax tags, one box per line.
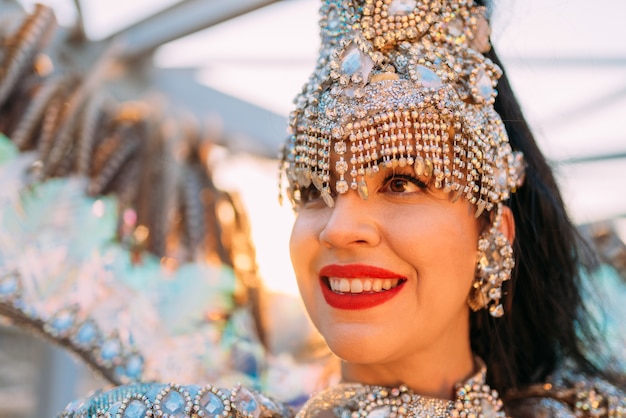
<box><xmin>319</xmin><ymin>192</ymin><xmax>381</xmax><ymax>248</ymax></box>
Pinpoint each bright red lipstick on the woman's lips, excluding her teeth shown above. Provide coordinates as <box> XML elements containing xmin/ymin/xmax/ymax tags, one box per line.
<box><xmin>320</xmin><ymin>264</ymin><xmax>405</xmax><ymax>310</ymax></box>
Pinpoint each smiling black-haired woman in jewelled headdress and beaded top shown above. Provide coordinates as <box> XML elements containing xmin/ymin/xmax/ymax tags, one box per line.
<box><xmin>56</xmin><ymin>0</ymin><xmax>626</xmax><ymax>417</ymax></box>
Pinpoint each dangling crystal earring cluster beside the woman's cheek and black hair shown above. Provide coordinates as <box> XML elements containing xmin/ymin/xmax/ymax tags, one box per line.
<box><xmin>467</xmin><ymin>204</ymin><xmax>515</xmax><ymax>318</ymax></box>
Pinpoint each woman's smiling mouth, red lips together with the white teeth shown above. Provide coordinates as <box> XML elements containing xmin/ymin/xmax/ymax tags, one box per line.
<box><xmin>320</xmin><ymin>264</ymin><xmax>406</xmax><ymax>310</ymax></box>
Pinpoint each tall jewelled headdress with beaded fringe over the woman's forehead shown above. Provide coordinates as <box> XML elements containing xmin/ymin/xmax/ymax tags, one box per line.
<box><xmin>281</xmin><ymin>0</ymin><xmax>524</xmax><ymax>216</ymax></box>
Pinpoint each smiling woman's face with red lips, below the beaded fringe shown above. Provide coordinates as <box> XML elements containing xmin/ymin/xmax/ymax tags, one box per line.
<box><xmin>290</xmin><ymin>158</ymin><xmax>479</xmax><ymax>364</ymax></box>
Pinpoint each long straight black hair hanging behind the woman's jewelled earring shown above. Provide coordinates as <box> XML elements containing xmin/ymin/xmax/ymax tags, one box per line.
<box><xmin>471</xmin><ymin>2</ymin><xmax>620</xmax><ymax>397</ymax></box>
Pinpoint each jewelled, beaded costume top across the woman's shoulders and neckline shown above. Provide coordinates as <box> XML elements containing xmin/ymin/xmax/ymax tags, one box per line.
<box><xmin>59</xmin><ymin>364</ymin><xmax>626</xmax><ymax>418</ymax></box>
